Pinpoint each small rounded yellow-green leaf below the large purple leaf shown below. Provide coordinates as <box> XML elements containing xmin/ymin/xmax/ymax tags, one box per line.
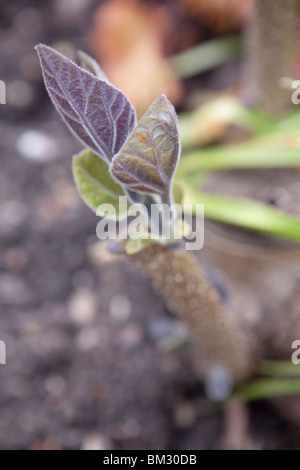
<box><xmin>73</xmin><ymin>149</ymin><xmax>125</xmax><ymax>217</ymax></box>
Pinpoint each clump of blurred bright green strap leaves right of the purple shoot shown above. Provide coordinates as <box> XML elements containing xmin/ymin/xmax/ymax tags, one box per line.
<box><xmin>176</xmin><ymin>97</ymin><xmax>300</xmax><ymax>242</ymax></box>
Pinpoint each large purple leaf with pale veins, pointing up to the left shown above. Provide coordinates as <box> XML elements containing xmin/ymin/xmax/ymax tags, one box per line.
<box><xmin>36</xmin><ymin>44</ymin><xmax>136</xmax><ymax>161</ymax></box>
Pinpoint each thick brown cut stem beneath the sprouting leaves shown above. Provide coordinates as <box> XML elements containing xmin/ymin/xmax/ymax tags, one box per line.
<box><xmin>129</xmin><ymin>244</ymin><xmax>253</xmax><ymax>381</ymax></box>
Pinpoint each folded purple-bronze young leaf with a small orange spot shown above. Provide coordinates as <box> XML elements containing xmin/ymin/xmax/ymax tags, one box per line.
<box><xmin>110</xmin><ymin>95</ymin><xmax>180</xmax><ymax>195</ymax></box>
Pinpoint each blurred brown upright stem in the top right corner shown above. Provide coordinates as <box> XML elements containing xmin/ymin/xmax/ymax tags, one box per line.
<box><xmin>245</xmin><ymin>0</ymin><xmax>298</xmax><ymax>116</ymax></box>
